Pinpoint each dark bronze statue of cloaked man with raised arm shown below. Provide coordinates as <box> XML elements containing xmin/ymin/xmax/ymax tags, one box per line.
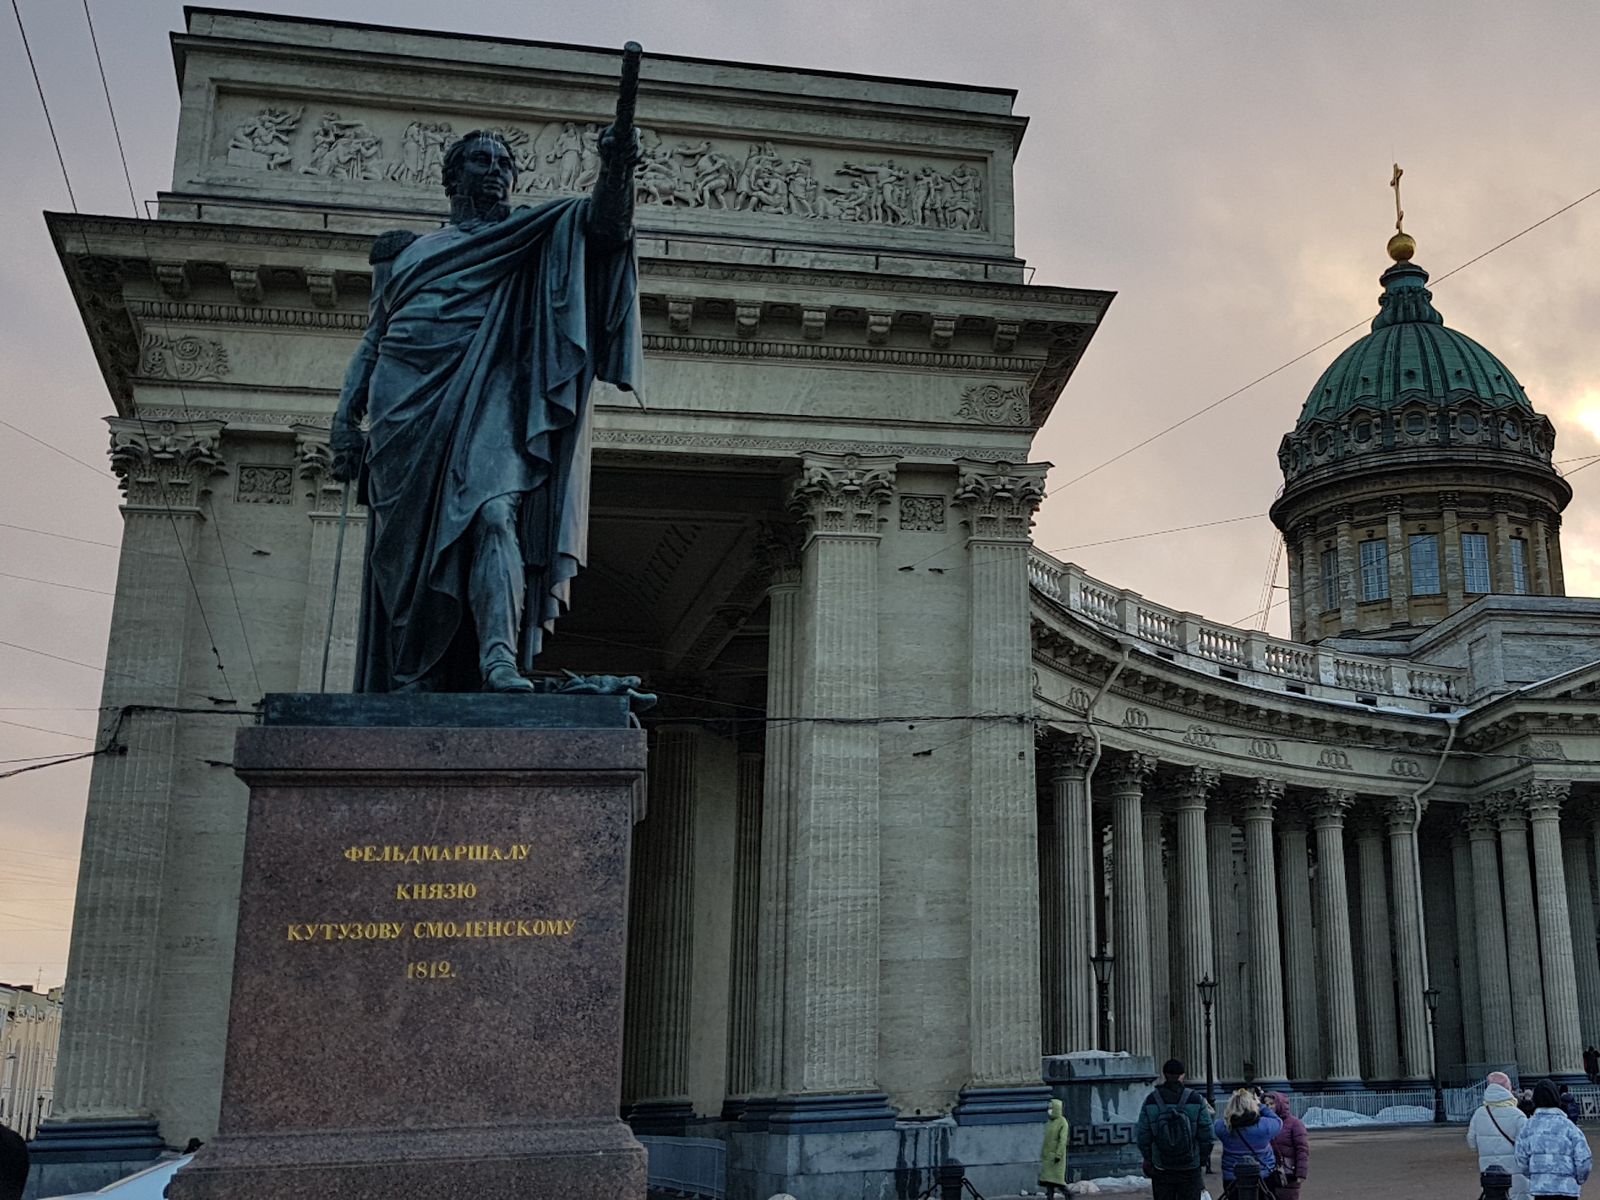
<box><xmin>333</xmin><ymin>58</ymin><xmax>642</xmax><ymax>691</ymax></box>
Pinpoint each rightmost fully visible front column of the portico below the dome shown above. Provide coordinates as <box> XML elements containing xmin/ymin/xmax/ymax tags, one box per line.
<box><xmin>1522</xmin><ymin>779</ymin><xmax>1584</xmax><ymax>1075</ymax></box>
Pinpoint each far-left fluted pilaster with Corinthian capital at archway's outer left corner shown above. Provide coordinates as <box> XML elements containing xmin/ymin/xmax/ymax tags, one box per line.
<box><xmin>40</xmin><ymin>418</ymin><xmax>224</xmax><ymax>1160</ymax></box>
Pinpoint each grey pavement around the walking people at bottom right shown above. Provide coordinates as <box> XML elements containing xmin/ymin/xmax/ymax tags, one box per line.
<box><xmin>989</xmin><ymin>1125</ymin><xmax>1600</xmax><ymax>1200</ymax></box>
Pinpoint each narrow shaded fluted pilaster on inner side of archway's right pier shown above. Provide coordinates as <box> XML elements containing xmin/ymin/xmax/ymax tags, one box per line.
<box><xmin>746</xmin><ymin>525</ymin><xmax>800</xmax><ymax>1117</ymax></box>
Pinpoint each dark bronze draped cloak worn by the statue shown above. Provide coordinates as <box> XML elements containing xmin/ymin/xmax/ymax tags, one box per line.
<box><xmin>352</xmin><ymin>198</ymin><xmax>642</xmax><ymax>691</ymax></box>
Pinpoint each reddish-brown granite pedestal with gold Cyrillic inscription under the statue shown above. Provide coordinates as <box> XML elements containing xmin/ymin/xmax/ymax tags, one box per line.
<box><xmin>168</xmin><ymin>696</ymin><xmax>645</xmax><ymax>1200</ymax></box>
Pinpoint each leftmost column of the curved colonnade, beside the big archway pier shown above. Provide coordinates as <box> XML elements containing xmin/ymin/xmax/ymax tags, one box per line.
<box><xmin>1040</xmin><ymin>734</ymin><xmax>1094</xmax><ymax>1054</ymax></box>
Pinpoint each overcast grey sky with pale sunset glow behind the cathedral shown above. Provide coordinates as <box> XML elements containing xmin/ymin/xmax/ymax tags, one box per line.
<box><xmin>0</xmin><ymin>0</ymin><xmax>1600</xmax><ymax>986</ymax></box>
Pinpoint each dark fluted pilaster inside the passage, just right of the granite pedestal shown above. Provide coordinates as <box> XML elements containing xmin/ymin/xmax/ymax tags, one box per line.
<box><xmin>622</xmin><ymin>726</ymin><xmax>702</xmax><ymax>1134</ymax></box>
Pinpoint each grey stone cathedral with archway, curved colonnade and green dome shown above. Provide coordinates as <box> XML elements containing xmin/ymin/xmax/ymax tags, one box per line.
<box><xmin>38</xmin><ymin>8</ymin><xmax>1600</xmax><ymax>1197</ymax></box>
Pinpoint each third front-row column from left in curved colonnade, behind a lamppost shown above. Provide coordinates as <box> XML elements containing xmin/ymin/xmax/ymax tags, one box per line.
<box><xmin>1157</xmin><ymin>766</ymin><xmax>1219</xmax><ymax>1078</ymax></box>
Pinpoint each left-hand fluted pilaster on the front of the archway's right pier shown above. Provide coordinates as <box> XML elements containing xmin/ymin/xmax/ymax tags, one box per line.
<box><xmin>771</xmin><ymin>454</ymin><xmax>902</xmax><ymax>1130</ymax></box>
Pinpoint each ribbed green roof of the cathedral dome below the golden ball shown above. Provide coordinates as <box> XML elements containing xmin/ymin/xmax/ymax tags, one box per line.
<box><xmin>1294</xmin><ymin>262</ymin><xmax>1533</xmax><ymax>429</ymax></box>
